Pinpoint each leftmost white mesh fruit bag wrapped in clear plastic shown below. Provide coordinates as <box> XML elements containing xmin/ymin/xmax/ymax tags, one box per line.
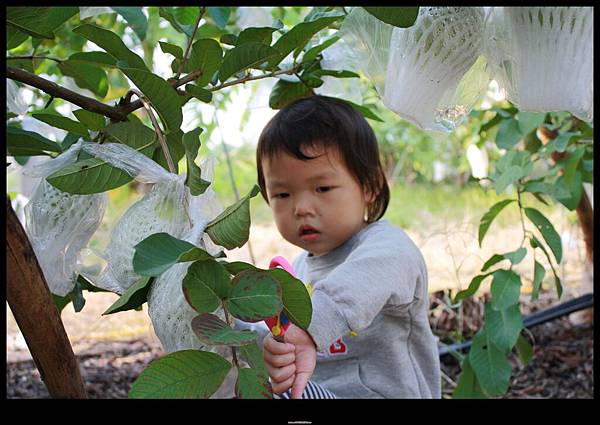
<box><xmin>23</xmin><ymin>141</ymin><xmax>107</xmax><ymax>296</ymax></box>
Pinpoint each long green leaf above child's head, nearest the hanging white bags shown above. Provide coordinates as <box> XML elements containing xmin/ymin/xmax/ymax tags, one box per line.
<box><xmin>269</xmin><ymin>11</ymin><xmax>344</xmax><ymax>68</ymax></box>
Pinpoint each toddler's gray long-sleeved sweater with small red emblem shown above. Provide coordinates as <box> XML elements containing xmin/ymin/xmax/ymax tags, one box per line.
<box><xmin>294</xmin><ymin>220</ymin><xmax>441</xmax><ymax>398</ymax></box>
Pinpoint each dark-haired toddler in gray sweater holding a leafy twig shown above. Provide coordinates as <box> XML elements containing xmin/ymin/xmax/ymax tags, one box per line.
<box><xmin>257</xmin><ymin>96</ymin><xmax>441</xmax><ymax>398</ymax></box>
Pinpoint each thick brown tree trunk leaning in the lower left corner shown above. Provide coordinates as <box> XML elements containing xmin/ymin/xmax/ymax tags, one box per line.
<box><xmin>6</xmin><ymin>196</ymin><xmax>87</xmax><ymax>398</ymax></box>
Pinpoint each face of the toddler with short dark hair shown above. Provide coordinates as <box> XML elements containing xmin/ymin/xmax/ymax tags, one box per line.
<box><xmin>262</xmin><ymin>149</ymin><xmax>370</xmax><ymax>255</ymax></box>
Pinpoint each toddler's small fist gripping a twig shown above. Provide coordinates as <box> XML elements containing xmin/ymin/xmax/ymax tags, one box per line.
<box><xmin>263</xmin><ymin>324</ymin><xmax>317</xmax><ymax>398</ymax></box>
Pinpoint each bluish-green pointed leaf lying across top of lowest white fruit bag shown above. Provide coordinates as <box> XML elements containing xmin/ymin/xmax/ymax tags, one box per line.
<box><xmin>132</xmin><ymin>232</ymin><xmax>214</xmax><ymax>276</ymax></box>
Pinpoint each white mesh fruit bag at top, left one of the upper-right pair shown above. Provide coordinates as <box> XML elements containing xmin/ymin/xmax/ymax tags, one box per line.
<box><xmin>339</xmin><ymin>7</ymin><xmax>490</xmax><ymax>131</ymax></box>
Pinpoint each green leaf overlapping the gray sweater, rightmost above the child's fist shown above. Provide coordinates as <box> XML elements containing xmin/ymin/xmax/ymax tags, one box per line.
<box><xmin>268</xmin><ymin>268</ymin><xmax>312</xmax><ymax>329</ymax></box>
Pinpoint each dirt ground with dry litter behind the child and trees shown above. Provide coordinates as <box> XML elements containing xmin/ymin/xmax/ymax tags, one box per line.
<box><xmin>7</xmin><ymin>218</ymin><xmax>593</xmax><ymax>398</ymax></box>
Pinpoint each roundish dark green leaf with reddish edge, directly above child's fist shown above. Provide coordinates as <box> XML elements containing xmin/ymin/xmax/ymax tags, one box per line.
<box><xmin>226</xmin><ymin>270</ymin><xmax>283</xmax><ymax>322</ymax></box>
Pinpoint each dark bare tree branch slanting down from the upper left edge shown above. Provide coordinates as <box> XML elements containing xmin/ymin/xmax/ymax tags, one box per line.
<box><xmin>6</xmin><ymin>66</ymin><xmax>126</xmax><ymax>121</ymax></box>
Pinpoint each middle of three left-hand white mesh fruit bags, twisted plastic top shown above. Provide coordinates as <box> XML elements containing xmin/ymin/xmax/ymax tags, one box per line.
<box><xmin>79</xmin><ymin>143</ymin><xmax>192</xmax><ymax>294</ymax></box>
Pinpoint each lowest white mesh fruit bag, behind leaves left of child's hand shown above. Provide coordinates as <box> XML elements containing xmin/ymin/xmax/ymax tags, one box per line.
<box><xmin>148</xmin><ymin>156</ymin><xmax>225</xmax><ymax>353</ymax></box>
